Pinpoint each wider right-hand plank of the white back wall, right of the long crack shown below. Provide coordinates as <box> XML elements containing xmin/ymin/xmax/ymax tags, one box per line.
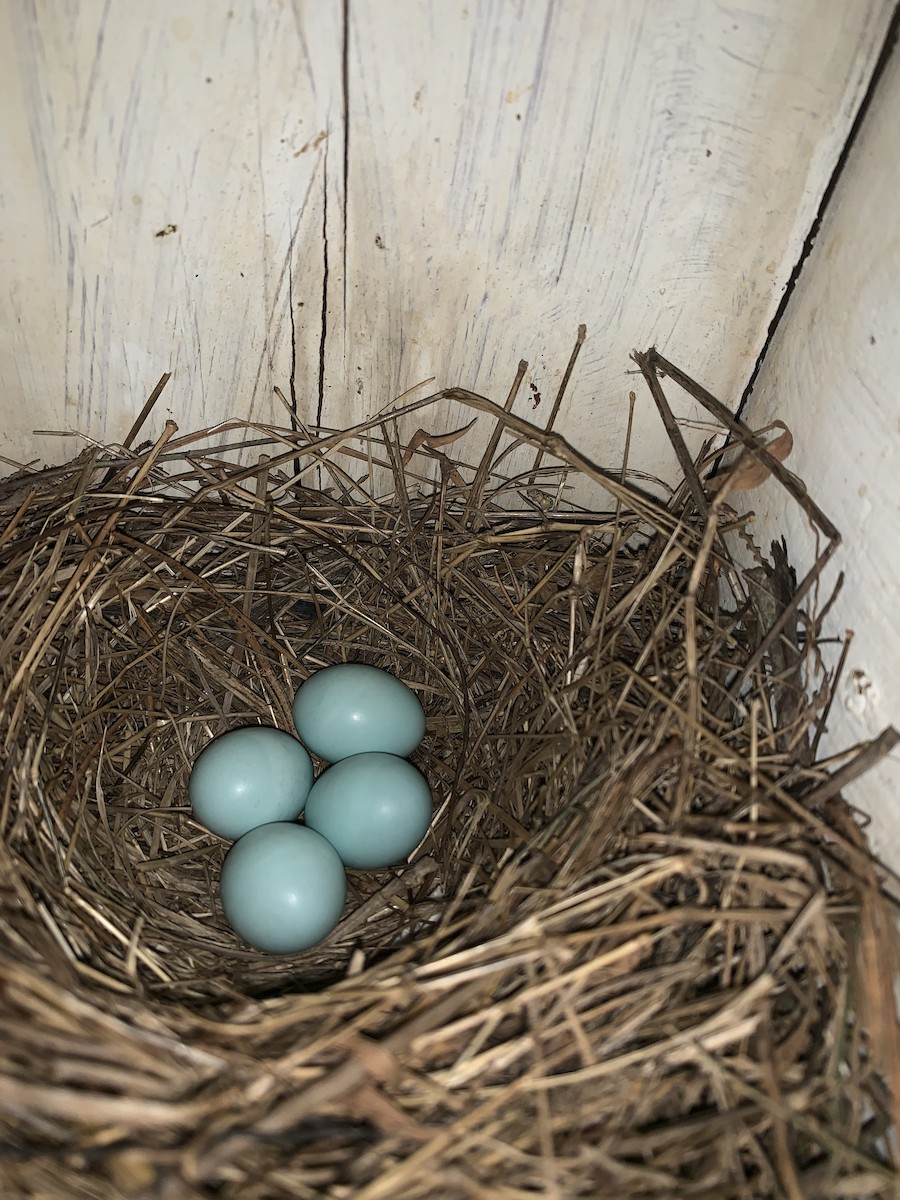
<box><xmin>326</xmin><ymin>0</ymin><xmax>889</xmax><ymax>487</ymax></box>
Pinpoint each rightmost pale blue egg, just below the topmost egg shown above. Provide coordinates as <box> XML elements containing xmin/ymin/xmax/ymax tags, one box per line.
<box><xmin>305</xmin><ymin>752</ymin><xmax>431</xmax><ymax>870</ymax></box>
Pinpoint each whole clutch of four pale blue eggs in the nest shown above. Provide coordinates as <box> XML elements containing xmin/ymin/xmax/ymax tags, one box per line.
<box><xmin>188</xmin><ymin>662</ymin><xmax>432</xmax><ymax>954</ymax></box>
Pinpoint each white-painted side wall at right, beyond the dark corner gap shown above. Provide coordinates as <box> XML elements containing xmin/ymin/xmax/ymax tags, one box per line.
<box><xmin>745</xmin><ymin>46</ymin><xmax>900</xmax><ymax>869</ymax></box>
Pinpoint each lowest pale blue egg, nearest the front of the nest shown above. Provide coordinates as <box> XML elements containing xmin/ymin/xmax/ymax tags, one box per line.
<box><xmin>218</xmin><ymin>822</ymin><xmax>347</xmax><ymax>954</ymax></box>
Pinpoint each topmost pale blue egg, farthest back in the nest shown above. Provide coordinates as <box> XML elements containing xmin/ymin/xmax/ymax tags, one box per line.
<box><xmin>294</xmin><ymin>662</ymin><xmax>425</xmax><ymax>762</ymax></box>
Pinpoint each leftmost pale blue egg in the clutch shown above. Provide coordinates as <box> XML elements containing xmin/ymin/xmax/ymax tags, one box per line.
<box><xmin>188</xmin><ymin>725</ymin><xmax>313</xmax><ymax>839</ymax></box>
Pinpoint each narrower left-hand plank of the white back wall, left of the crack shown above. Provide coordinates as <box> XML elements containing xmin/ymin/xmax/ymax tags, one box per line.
<box><xmin>0</xmin><ymin>0</ymin><xmax>343</xmax><ymax>458</ymax></box>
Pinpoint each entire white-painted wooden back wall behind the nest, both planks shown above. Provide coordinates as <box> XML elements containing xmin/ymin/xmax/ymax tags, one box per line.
<box><xmin>0</xmin><ymin>0</ymin><xmax>892</xmax><ymax>482</ymax></box>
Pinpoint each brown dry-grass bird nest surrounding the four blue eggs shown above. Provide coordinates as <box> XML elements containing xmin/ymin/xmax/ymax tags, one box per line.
<box><xmin>0</xmin><ymin>352</ymin><xmax>898</xmax><ymax>1200</ymax></box>
